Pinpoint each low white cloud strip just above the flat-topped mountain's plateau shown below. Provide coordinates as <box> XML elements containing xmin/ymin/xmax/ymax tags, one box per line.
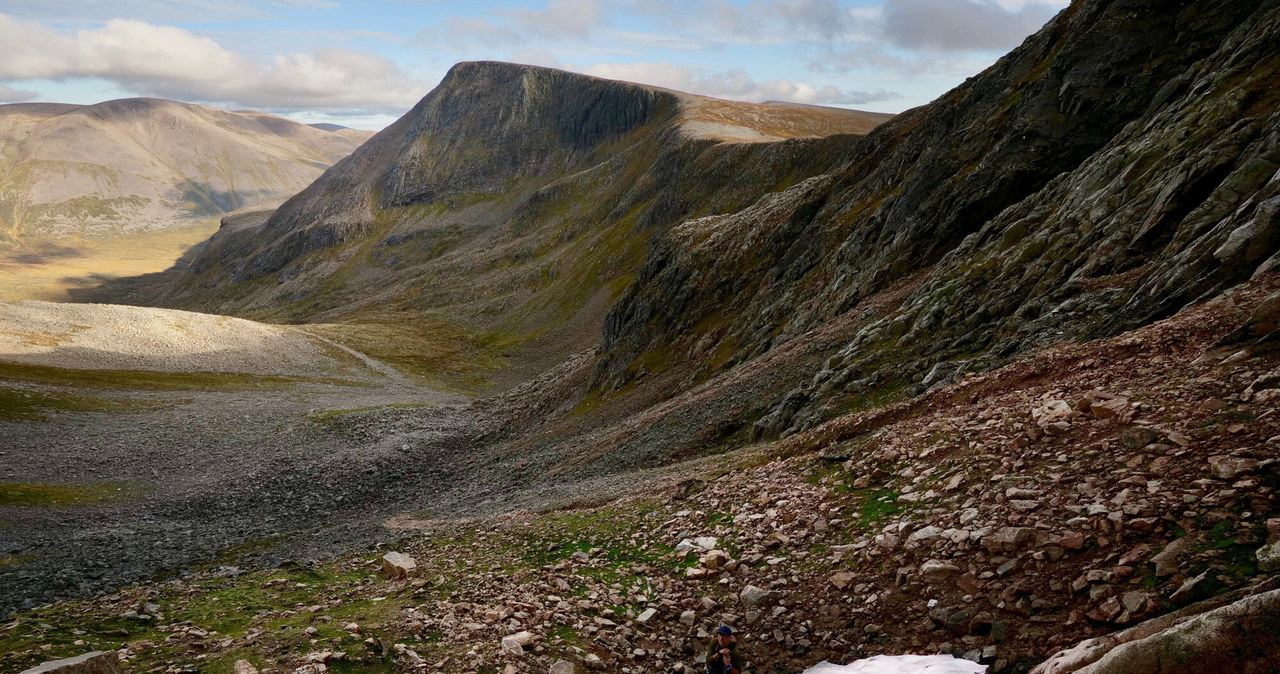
<box><xmin>582</xmin><ymin>63</ymin><xmax>896</xmax><ymax>105</ymax></box>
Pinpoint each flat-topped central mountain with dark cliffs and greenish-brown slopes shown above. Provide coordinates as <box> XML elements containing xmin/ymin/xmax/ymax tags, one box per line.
<box><xmin>147</xmin><ymin>63</ymin><xmax>888</xmax><ymax>376</ymax></box>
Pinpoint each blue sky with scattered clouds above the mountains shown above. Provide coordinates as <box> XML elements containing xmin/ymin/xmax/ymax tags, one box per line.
<box><xmin>0</xmin><ymin>0</ymin><xmax>1068</xmax><ymax>129</ymax></box>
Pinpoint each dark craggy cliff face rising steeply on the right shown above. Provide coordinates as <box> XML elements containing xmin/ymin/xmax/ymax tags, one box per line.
<box><xmin>593</xmin><ymin>0</ymin><xmax>1280</xmax><ymax>435</ymax></box>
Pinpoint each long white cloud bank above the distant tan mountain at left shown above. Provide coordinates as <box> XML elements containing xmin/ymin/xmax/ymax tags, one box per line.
<box><xmin>0</xmin><ymin>14</ymin><xmax>428</xmax><ymax>110</ymax></box>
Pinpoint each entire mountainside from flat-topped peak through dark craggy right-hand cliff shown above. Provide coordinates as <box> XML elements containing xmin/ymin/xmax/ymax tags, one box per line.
<box><xmin>157</xmin><ymin>0</ymin><xmax>1280</xmax><ymax>452</ymax></box>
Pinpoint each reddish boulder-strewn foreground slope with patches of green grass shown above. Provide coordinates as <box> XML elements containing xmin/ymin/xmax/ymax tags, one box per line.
<box><xmin>0</xmin><ymin>274</ymin><xmax>1280</xmax><ymax>673</ymax></box>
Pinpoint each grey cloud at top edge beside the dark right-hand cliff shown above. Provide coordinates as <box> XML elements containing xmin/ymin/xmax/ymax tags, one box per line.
<box><xmin>884</xmin><ymin>0</ymin><xmax>1060</xmax><ymax>51</ymax></box>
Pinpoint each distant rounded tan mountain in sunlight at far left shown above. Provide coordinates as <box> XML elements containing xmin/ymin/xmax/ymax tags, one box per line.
<box><xmin>0</xmin><ymin>98</ymin><xmax>371</xmax><ymax>248</ymax></box>
